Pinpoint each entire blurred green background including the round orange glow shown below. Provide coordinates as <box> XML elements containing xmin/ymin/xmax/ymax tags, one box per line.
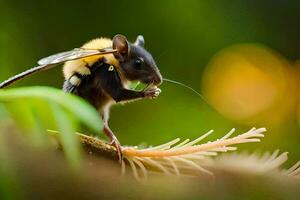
<box><xmin>0</xmin><ymin>0</ymin><xmax>300</xmax><ymax>165</ymax></box>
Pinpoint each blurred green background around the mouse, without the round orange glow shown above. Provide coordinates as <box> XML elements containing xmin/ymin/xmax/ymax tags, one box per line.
<box><xmin>0</xmin><ymin>0</ymin><xmax>300</xmax><ymax>162</ymax></box>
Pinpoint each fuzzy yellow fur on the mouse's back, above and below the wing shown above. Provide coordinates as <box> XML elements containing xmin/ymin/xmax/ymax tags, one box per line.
<box><xmin>63</xmin><ymin>38</ymin><xmax>119</xmax><ymax>80</ymax></box>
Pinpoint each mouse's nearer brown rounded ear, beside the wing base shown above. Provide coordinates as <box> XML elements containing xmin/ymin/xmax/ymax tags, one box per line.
<box><xmin>112</xmin><ymin>34</ymin><xmax>130</xmax><ymax>61</ymax></box>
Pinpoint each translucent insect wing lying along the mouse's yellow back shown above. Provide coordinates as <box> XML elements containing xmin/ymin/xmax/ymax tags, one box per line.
<box><xmin>38</xmin><ymin>48</ymin><xmax>116</xmax><ymax>65</ymax></box>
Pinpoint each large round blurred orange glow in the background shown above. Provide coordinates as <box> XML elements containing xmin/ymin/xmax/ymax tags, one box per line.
<box><xmin>203</xmin><ymin>44</ymin><xmax>297</xmax><ymax>125</ymax></box>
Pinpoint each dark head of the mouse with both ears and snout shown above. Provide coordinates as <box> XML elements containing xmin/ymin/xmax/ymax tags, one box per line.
<box><xmin>112</xmin><ymin>34</ymin><xmax>162</xmax><ymax>85</ymax></box>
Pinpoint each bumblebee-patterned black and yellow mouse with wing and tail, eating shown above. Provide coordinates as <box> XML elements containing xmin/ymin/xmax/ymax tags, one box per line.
<box><xmin>0</xmin><ymin>34</ymin><xmax>163</xmax><ymax>160</ymax></box>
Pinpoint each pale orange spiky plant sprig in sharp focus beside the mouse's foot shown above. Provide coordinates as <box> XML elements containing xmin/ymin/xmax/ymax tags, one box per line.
<box><xmin>123</xmin><ymin>128</ymin><xmax>268</xmax><ymax>180</ymax></box>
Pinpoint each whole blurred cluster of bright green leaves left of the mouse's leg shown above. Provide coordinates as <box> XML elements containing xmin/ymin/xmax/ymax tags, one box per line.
<box><xmin>0</xmin><ymin>87</ymin><xmax>102</xmax><ymax>167</ymax></box>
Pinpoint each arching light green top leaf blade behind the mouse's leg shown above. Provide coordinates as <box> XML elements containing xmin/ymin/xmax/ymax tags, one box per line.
<box><xmin>0</xmin><ymin>86</ymin><xmax>103</xmax><ymax>133</ymax></box>
